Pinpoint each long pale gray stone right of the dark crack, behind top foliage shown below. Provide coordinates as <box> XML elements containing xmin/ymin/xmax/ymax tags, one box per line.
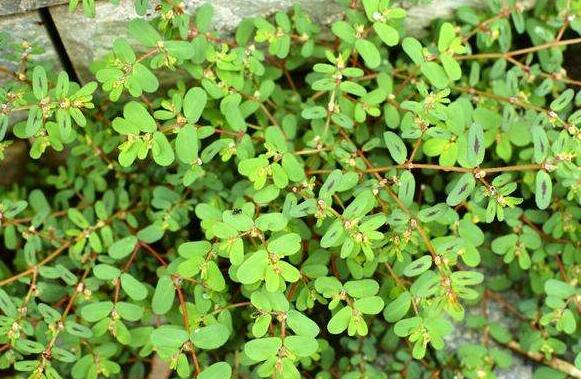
<box><xmin>50</xmin><ymin>0</ymin><xmax>484</xmax><ymax>81</ymax></box>
